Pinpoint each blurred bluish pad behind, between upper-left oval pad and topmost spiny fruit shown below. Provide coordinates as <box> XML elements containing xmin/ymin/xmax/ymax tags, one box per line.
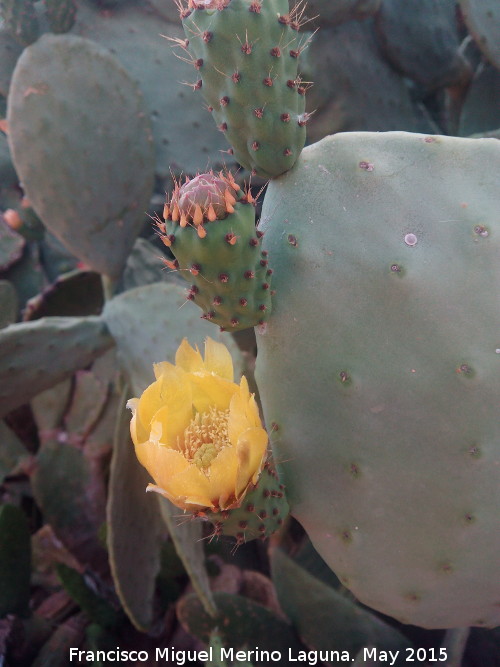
<box><xmin>74</xmin><ymin>0</ymin><xmax>233</xmax><ymax>179</ymax></box>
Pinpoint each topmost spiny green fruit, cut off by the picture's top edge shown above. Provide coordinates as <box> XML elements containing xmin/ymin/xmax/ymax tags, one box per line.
<box><xmin>180</xmin><ymin>0</ymin><xmax>309</xmax><ymax>178</ymax></box>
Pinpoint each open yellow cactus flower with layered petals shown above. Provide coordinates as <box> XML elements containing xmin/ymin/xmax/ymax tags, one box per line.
<box><xmin>127</xmin><ymin>338</ymin><xmax>268</xmax><ymax>511</ymax></box>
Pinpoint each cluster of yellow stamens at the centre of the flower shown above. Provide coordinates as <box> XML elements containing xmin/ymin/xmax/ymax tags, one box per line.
<box><xmin>179</xmin><ymin>406</ymin><xmax>230</xmax><ymax>473</ymax></box>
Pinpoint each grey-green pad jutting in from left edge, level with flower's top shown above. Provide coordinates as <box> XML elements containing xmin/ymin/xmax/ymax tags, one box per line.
<box><xmin>0</xmin><ymin>317</ymin><xmax>113</xmax><ymax>416</ymax></box>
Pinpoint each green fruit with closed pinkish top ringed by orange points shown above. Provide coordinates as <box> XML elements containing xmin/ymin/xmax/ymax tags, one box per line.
<box><xmin>157</xmin><ymin>172</ymin><xmax>272</xmax><ymax>331</ymax></box>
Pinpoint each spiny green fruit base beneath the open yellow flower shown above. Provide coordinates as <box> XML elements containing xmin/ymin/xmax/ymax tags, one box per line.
<box><xmin>195</xmin><ymin>461</ymin><xmax>289</xmax><ymax>544</ymax></box>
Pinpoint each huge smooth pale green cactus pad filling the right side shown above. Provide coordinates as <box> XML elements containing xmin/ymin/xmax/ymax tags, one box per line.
<box><xmin>256</xmin><ymin>132</ymin><xmax>500</xmax><ymax>628</ymax></box>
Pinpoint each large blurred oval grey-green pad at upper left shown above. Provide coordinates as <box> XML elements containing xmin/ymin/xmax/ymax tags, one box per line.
<box><xmin>7</xmin><ymin>35</ymin><xmax>154</xmax><ymax>277</ymax></box>
